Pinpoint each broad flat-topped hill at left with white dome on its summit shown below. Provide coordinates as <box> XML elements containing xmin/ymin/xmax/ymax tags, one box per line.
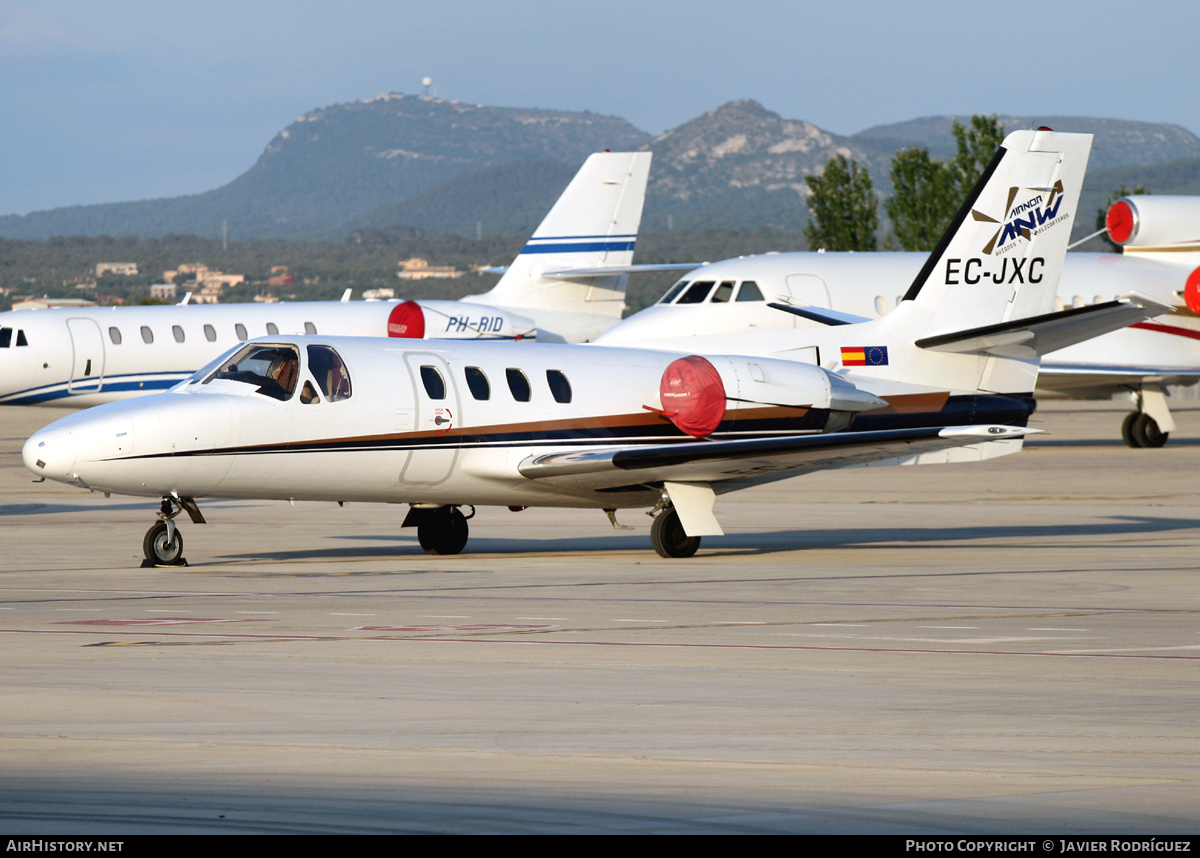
<box><xmin>0</xmin><ymin>94</ymin><xmax>650</xmax><ymax>238</ymax></box>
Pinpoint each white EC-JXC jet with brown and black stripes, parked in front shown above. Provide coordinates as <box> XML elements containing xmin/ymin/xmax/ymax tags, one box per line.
<box><xmin>23</xmin><ymin>131</ymin><xmax>1164</xmax><ymax>565</ymax></box>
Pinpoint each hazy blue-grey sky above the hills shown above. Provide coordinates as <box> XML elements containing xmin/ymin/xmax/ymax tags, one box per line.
<box><xmin>0</xmin><ymin>0</ymin><xmax>1200</xmax><ymax>214</ymax></box>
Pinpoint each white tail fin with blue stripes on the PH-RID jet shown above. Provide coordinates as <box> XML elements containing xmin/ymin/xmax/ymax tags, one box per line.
<box><xmin>463</xmin><ymin>152</ymin><xmax>650</xmax><ymax>319</ymax></box>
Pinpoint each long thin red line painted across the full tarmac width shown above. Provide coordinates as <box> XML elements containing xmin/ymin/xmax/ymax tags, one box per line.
<box><xmin>0</xmin><ymin>629</ymin><xmax>1200</xmax><ymax>661</ymax></box>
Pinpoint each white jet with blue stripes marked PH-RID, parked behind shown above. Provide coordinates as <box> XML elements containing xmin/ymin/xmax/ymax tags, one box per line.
<box><xmin>0</xmin><ymin>152</ymin><xmax>683</xmax><ymax>407</ymax></box>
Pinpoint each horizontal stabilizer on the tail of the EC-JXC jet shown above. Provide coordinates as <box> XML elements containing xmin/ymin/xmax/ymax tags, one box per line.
<box><xmin>916</xmin><ymin>293</ymin><xmax>1171</xmax><ymax>358</ymax></box>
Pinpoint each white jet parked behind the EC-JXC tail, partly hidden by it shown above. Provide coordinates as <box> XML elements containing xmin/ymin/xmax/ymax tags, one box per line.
<box><xmin>595</xmin><ymin>196</ymin><xmax>1200</xmax><ymax>446</ymax></box>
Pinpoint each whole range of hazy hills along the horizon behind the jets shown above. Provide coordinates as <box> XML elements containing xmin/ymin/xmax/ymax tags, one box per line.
<box><xmin>0</xmin><ymin>94</ymin><xmax>1200</xmax><ymax>240</ymax></box>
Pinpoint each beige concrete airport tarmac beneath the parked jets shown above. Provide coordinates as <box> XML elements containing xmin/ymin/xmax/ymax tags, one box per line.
<box><xmin>0</xmin><ymin>402</ymin><xmax>1200</xmax><ymax>836</ymax></box>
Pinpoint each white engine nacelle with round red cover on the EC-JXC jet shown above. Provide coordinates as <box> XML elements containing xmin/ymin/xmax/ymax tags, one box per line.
<box><xmin>659</xmin><ymin>355</ymin><xmax>887</xmax><ymax>438</ymax></box>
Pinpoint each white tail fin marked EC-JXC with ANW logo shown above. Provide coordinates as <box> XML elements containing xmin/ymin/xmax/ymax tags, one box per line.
<box><xmin>827</xmin><ymin>131</ymin><xmax>1099</xmax><ymax>395</ymax></box>
